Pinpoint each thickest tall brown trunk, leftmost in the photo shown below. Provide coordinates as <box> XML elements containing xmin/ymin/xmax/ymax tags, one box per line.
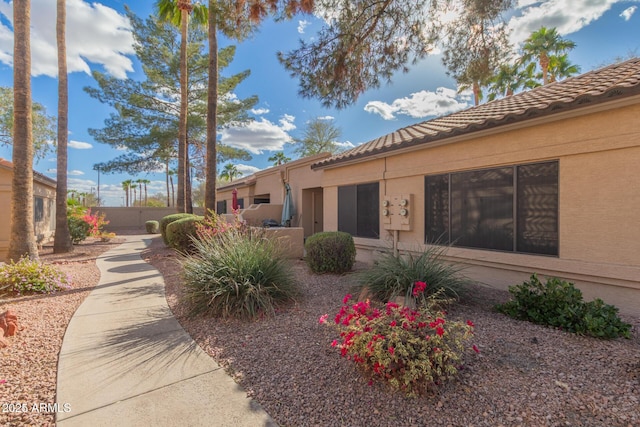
<box><xmin>7</xmin><ymin>0</ymin><xmax>38</xmax><ymax>261</ymax></box>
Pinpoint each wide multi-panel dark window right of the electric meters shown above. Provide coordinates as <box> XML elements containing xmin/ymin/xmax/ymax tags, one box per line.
<box><xmin>425</xmin><ymin>161</ymin><xmax>558</xmax><ymax>255</ymax></box>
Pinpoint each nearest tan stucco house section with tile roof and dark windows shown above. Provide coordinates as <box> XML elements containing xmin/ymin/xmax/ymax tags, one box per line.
<box><xmin>311</xmin><ymin>59</ymin><xmax>640</xmax><ymax>314</ymax></box>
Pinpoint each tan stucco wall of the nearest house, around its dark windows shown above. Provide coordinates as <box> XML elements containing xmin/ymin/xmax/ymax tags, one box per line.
<box><xmin>312</xmin><ymin>60</ymin><xmax>640</xmax><ymax>315</ymax></box>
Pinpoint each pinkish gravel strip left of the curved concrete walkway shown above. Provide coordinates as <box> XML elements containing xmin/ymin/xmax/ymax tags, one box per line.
<box><xmin>0</xmin><ymin>238</ymin><xmax>124</xmax><ymax>426</ymax></box>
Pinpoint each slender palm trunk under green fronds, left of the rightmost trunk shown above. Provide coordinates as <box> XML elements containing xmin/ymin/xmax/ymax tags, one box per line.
<box><xmin>178</xmin><ymin>6</ymin><xmax>191</xmax><ymax>212</ymax></box>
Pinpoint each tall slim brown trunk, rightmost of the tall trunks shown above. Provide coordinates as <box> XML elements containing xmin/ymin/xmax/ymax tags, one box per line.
<box><xmin>204</xmin><ymin>0</ymin><xmax>218</xmax><ymax>215</ymax></box>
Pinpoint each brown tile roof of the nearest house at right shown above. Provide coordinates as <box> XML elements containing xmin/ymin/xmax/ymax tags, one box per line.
<box><xmin>311</xmin><ymin>58</ymin><xmax>640</xmax><ymax>169</ymax></box>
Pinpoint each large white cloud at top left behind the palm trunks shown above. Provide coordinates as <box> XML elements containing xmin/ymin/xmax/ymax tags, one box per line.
<box><xmin>0</xmin><ymin>0</ymin><xmax>134</xmax><ymax>79</ymax></box>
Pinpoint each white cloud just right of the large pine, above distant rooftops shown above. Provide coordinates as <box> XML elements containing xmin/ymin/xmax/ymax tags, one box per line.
<box><xmin>221</xmin><ymin>115</ymin><xmax>296</xmax><ymax>154</ymax></box>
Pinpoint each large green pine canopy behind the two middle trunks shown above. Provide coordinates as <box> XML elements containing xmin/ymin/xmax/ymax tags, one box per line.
<box><xmin>85</xmin><ymin>11</ymin><xmax>257</xmax><ymax>174</ymax></box>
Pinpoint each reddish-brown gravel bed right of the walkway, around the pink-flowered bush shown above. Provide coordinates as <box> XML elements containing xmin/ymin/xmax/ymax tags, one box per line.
<box><xmin>143</xmin><ymin>239</ymin><xmax>640</xmax><ymax>427</ymax></box>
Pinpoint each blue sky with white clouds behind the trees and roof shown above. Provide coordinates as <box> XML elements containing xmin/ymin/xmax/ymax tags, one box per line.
<box><xmin>0</xmin><ymin>0</ymin><xmax>640</xmax><ymax>206</ymax></box>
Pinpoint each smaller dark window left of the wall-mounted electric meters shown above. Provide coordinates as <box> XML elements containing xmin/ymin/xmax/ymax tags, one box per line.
<box><xmin>338</xmin><ymin>182</ymin><xmax>380</xmax><ymax>239</ymax></box>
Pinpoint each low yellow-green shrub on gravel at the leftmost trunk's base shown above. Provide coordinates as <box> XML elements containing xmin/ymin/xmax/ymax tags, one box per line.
<box><xmin>0</xmin><ymin>257</ymin><xmax>71</xmax><ymax>295</ymax></box>
